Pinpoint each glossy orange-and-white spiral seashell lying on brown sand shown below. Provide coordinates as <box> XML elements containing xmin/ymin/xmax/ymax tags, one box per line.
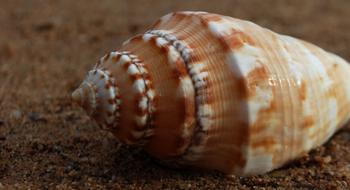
<box><xmin>72</xmin><ymin>12</ymin><xmax>350</xmax><ymax>175</ymax></box>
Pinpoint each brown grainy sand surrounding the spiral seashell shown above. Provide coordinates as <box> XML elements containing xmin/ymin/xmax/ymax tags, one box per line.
<box><xmin>0</xmin><ymin>0</ymin><xmax>350</xmax><ymax>189</ymax></box>
